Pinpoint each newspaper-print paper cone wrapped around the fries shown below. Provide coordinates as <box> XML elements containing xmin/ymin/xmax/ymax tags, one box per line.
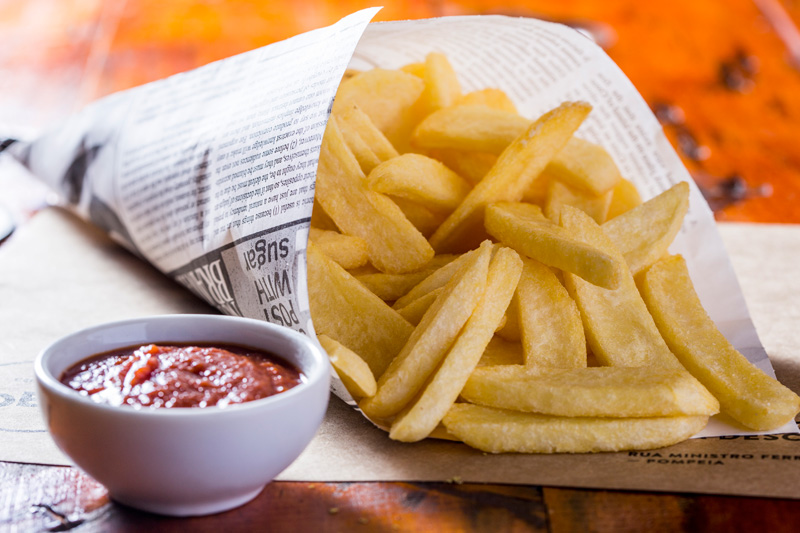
<box><xmin>3</xmin><ymin>9</ymin><xmax>797</xmax><ymax>436</ymax></box>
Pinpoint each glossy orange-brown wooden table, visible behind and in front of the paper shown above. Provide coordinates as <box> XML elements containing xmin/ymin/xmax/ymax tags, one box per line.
<box><xmin>0</xmin><ymin>0</ymin><xmax>800</xmax><ymax>532</ymax></box>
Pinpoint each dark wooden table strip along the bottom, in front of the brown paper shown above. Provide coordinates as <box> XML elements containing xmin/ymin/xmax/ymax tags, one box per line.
<box><xmin>0</xmin><ymin>463</ymin><xmax>800</xmax><ymax>533</ymax></box>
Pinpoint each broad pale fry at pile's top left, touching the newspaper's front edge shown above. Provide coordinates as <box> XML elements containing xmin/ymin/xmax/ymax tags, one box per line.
<box><xmin>333</xmin><ymin>69</ymin><xmax>425</xmax><ymax>152</ymax></box>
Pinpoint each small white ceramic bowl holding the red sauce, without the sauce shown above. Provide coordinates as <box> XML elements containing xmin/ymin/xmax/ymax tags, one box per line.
<box><xmin>35</xmin><ymin>315</ymin><xmax>330</xmax><ymax>516</ymax></box>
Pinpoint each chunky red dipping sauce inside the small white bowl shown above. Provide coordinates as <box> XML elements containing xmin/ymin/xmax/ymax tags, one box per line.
<box><xmin>61</xmin><ymin>344</ymin><xmax>303</xmax><ymax>408</ymax></box>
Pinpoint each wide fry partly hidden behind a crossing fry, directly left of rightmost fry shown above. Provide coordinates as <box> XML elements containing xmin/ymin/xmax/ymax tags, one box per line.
<box><xmin>561</xmin><ymin>205</ymin><xmax>680</xmax><ymax>368</ymax></box>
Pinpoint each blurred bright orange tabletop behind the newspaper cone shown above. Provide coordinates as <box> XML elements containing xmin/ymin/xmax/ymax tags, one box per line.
<box><xmin>0</xmin><ymin>0</ymin><xmax>800</xmax><ymax>223</ymax></box>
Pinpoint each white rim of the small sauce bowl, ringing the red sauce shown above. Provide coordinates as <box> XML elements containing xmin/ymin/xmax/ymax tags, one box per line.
<box><xmin>33</xmin><ymin>313</ymin><xmax>330</xmax><ymax>417</ymax></box>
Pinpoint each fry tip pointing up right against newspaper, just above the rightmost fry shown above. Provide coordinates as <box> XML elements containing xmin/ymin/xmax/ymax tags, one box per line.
<box><xmin>603</xmin><ymin>181</ymin><xmax>689</xmax><ymax>276</ymax></box>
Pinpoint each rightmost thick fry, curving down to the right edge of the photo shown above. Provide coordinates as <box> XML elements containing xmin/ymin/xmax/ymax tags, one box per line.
<box><xmin>639</xmin><ymin>251</ymin><xmax>800</xmax><ymax>431</ymax></box>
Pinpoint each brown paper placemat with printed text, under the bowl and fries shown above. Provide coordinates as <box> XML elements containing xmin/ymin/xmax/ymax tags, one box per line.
<box><xmin>0</xmin><ymin>209</ymin><xmax>800</xmax><ymax>498</ymax></box>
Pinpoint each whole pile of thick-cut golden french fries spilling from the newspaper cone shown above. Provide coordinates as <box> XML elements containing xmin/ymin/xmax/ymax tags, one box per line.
<box><xmin>308</xmin><ymin>53</ymin><xmax>800</xmax><ymax>453</ymax></box>
